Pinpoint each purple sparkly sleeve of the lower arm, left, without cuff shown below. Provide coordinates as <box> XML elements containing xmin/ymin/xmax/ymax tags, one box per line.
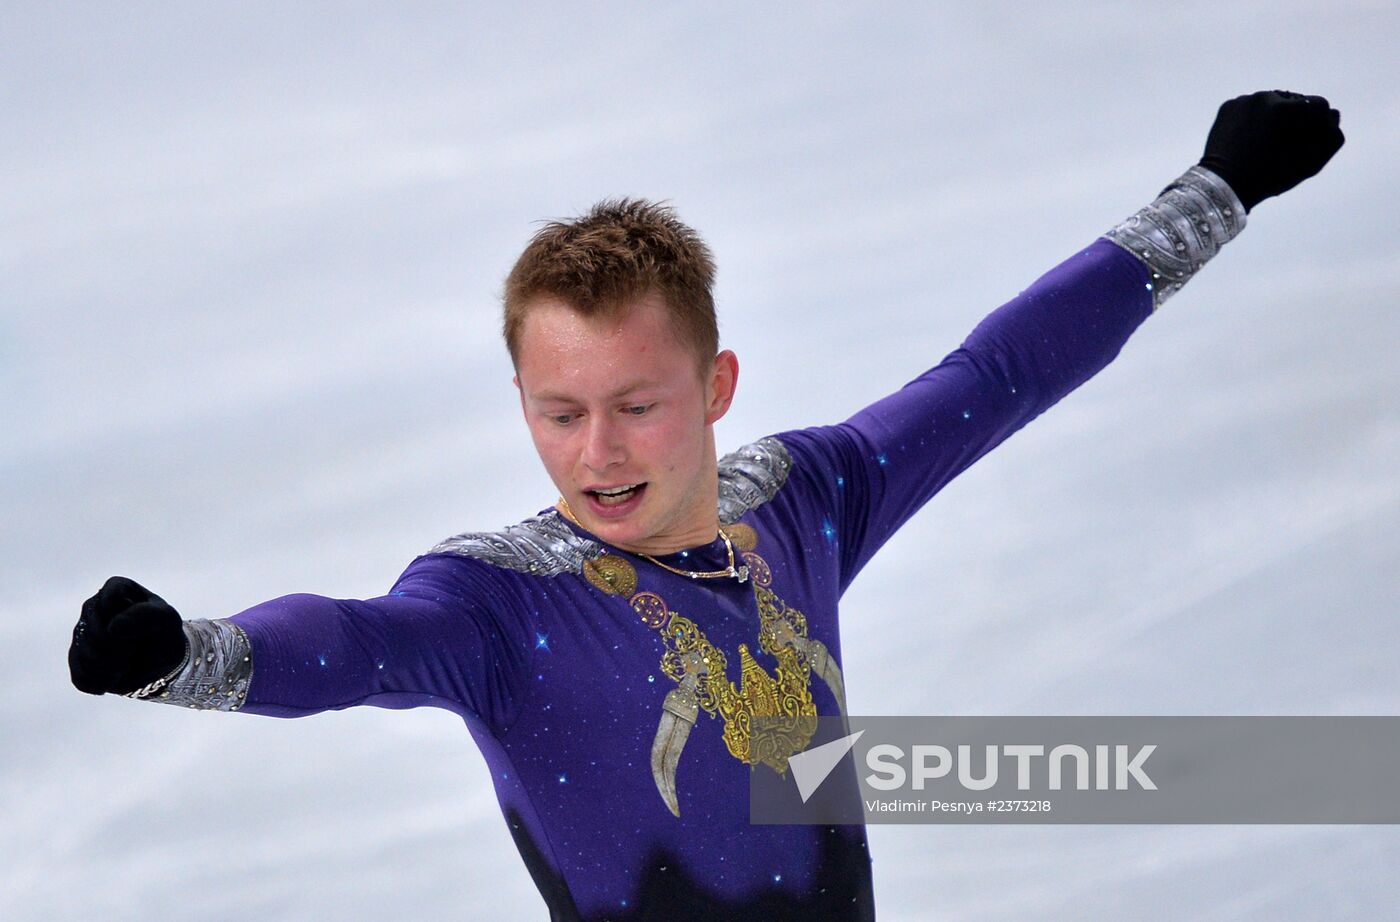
<box><xmin>228</xmin><ymin>554</ymin><xmax>532</xmax><ymax>729</ymax></box>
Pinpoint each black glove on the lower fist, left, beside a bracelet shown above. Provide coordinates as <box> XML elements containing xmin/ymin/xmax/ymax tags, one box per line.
<box><xmin>69</xmin><ymin>576</ymin><xmax>186</xmax><ymax>695</ymax></box>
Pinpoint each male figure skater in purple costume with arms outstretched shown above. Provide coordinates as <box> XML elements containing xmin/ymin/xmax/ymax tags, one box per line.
<box><xmin>69</xmin><ymin>91</ymin><xmax>1343</xmax><ymax>922</ymax></box>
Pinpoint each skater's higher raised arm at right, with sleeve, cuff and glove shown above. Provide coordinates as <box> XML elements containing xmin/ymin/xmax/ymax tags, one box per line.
<box><xmin>778</xmin><ymin>91</ymin><xmax>1343</xmax><ymax>589</ymax></box>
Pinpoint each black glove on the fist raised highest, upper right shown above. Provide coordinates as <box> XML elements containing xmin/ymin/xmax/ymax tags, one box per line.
<box><xmin>1200</xmin><ymin>90</ymin><xmax>1345</xmax><ymax>213</ymax></box>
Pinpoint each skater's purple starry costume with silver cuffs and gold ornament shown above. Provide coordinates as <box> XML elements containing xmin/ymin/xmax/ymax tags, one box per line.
<box><xmin>155</xmin><ymin>168</ymin><xmax>1245</xmax><ymax>922</ymax></box>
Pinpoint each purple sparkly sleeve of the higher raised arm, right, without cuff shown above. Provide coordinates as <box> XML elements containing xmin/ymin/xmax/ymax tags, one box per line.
<box><xmin>778</xmin><ymin>238</ymin><xmax>1152</xmax><ymax>590</ymax></box>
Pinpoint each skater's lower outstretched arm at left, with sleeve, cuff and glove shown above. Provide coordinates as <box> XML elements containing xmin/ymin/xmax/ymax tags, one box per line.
<box><xmin>69</xmin><ymin>555</ymin><xmax>533</xmax><ymax>729</ymax></box>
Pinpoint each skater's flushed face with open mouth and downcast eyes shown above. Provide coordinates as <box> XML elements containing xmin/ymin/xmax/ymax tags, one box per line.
<box><xmin>515</xmin><ymin>295</ymin><xmax>739</xmax><ymax>554</ymax></box>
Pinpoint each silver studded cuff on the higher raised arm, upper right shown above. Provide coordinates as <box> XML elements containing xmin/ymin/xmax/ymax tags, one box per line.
<box><xmin>1105</xmin><ymin>166</ymin><xmax>1245</xmax><ymax>311</ymax></box>
